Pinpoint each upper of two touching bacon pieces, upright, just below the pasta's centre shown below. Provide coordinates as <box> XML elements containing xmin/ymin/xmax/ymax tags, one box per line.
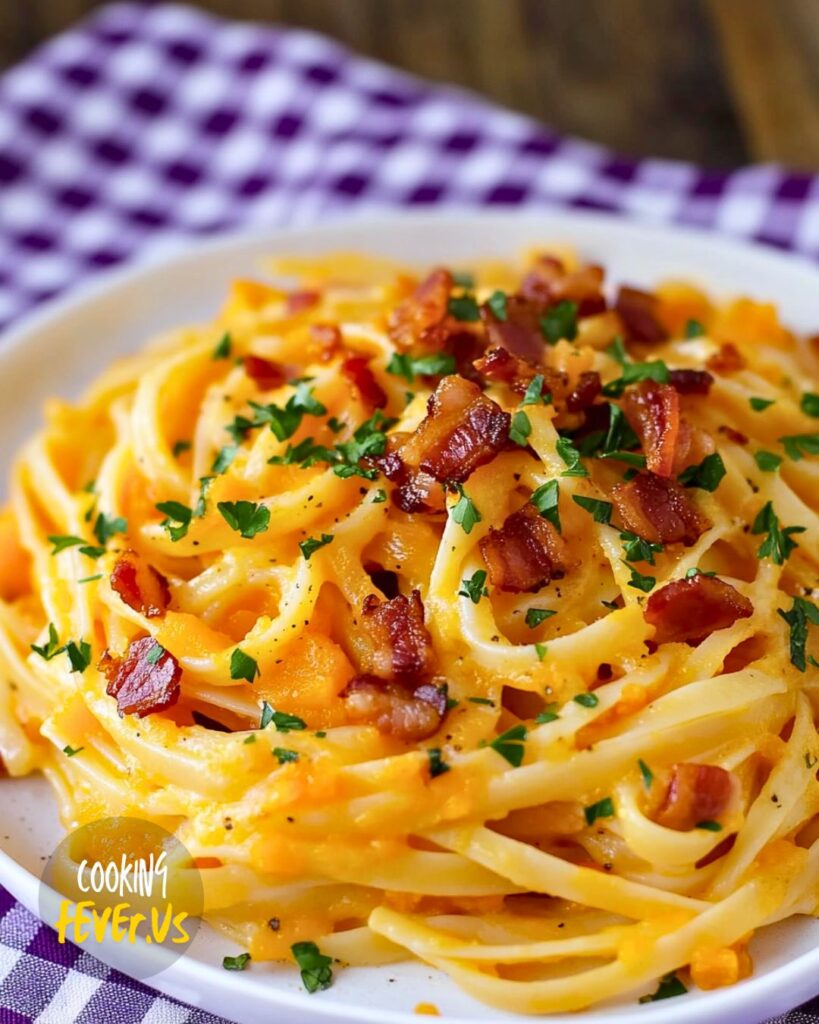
<box><xmin>361</xmin><ymin>590</ymin><xmax>433</xmax><ymax>683</ymax></box>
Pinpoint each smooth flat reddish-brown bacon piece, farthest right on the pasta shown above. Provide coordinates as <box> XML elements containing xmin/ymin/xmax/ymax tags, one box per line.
<box><xmin>644</xmin><ymin>573</ymin><xmax>753</xmax><ymax>644</ymax></box>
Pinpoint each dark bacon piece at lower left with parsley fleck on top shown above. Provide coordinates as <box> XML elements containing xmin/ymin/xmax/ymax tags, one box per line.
<box><xmin>98</xmin><ymin>637</ymin><xmax>182</xmax><ymax>718</ymax></box>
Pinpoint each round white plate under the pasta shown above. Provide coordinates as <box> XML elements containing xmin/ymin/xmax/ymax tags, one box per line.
<box><xmin>0</xmin><ymin>211</ymin><xmax>819</xmax><ymax>1024</ymax></box>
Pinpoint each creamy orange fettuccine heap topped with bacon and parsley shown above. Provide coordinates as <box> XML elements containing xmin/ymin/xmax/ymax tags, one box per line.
<box><xmin>0</xmin><ymin>250</ymin><xmax>819</xmax><ymax>1014</ymax></box>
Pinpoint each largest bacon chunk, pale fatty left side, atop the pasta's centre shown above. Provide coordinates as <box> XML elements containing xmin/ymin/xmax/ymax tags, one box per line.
<box><xmin>399</xmin><ymin>375</ymin><xmax>511</xmax><ymax>483</ymax></box>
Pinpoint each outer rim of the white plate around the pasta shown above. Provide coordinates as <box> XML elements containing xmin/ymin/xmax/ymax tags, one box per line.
<box><xmin>0</xmin><ymin>207</ymin><xmax>819</xmax><ymax>1024</ymax></box>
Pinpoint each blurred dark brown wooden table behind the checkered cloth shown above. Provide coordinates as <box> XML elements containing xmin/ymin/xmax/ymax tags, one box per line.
<box><xmin>0</xmin><ymin>0</ymin><xmax>819</xmax><ymax>171</ymax></box>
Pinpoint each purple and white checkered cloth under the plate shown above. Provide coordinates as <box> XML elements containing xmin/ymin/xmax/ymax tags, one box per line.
<box><xmin>0</xmin><ymin>4</ymin><xmax>819</xmax><ymax>1024</ymax></box>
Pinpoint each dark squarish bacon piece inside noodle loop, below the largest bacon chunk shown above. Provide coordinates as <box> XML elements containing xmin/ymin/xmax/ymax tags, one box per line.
<box><xmin>480</xmin><ymin>502</ymin><xmax>564</xmax><ymax>594</ymax></box>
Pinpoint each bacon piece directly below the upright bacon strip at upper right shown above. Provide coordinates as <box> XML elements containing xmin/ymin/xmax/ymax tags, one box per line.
<box><xmin>611</xmin><ymin>472</ymin><xmax>710</xmax><ymax>544</ymax></box>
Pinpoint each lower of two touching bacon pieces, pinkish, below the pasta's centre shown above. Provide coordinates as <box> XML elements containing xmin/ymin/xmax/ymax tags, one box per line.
<box><xmin>341</xmin><ymin>676</ymin><xmax>446</xmax><ymax>743</ymax></box>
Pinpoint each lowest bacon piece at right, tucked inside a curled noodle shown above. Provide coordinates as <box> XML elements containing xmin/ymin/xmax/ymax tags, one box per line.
<box><xmin>648</xmin><ymin>762</ymin><xmax>738</xmax><ymax>831</ymax></box>
